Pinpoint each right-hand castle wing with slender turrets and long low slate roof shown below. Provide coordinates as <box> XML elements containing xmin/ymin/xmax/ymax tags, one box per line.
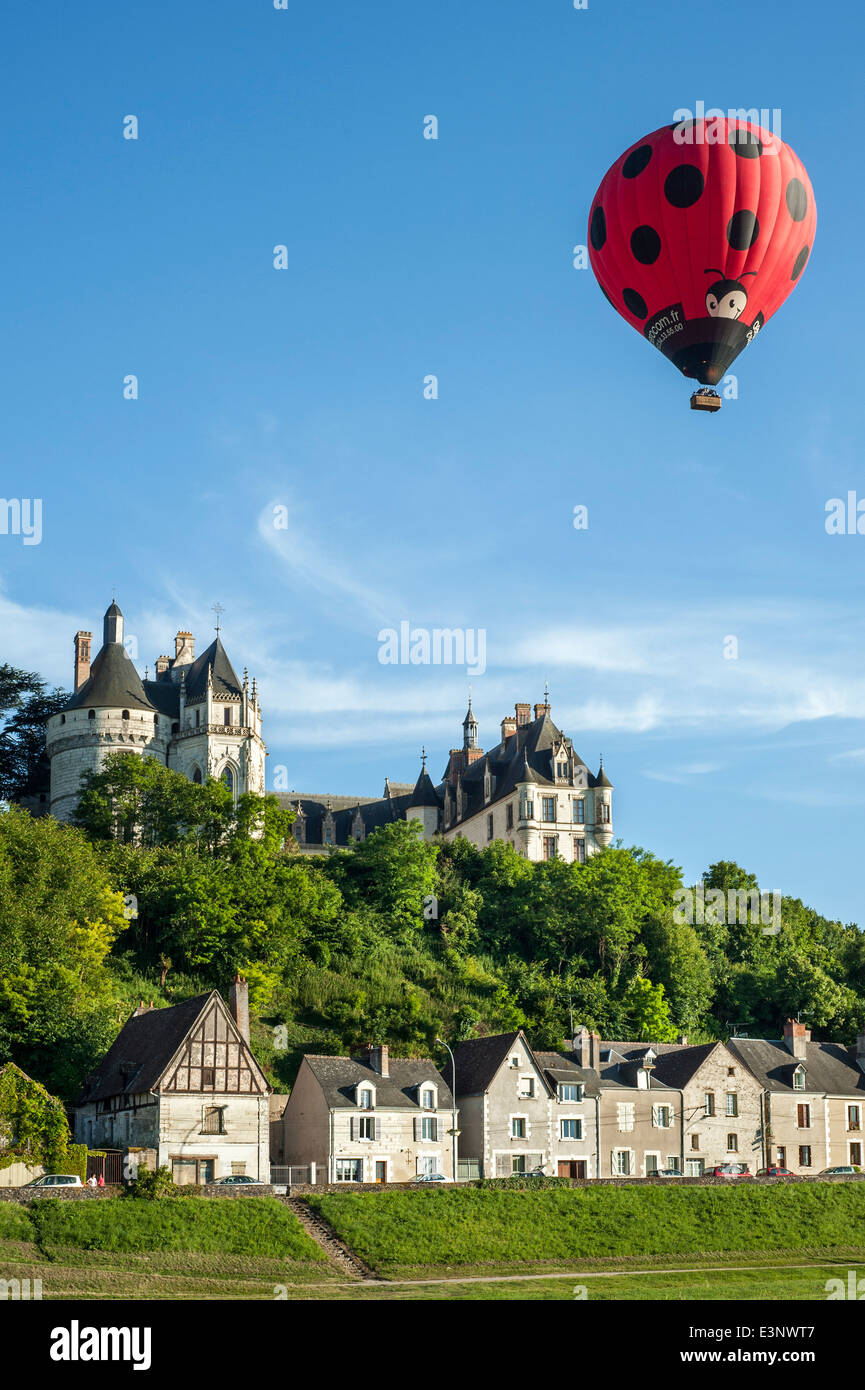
<box><xmin>280</xmin><ymin>696</ymin><xmax>613</xmax><ymax>863</ymax></box>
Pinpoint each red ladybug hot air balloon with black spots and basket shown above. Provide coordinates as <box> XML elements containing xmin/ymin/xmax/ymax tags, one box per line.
<box><xmin>588</xmin><ymin>115</ymin><xmax>816</xmax><ymax>410</ymax></box>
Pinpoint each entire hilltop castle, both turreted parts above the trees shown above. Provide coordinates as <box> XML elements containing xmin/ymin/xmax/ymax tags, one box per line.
<box><xmin>46</xmin><ymin>603</ymin><xmax>613</xmax><ymax>863</ymax></box>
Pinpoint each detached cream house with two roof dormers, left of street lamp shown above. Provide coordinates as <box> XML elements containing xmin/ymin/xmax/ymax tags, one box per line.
<box><xmin>284</xmin><ymin>1045</ymin><xmax>455</xmax><ymax>1183</ymax></box>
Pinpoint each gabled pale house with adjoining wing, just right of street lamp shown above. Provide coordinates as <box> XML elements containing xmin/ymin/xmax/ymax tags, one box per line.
<box><xmin>444</xmin><ymin>1029</ymin><xmax>598</xmax><ymax>1177</ymax></box>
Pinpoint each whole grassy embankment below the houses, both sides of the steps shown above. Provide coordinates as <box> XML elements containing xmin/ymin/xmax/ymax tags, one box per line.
<box><xmin>0</xmin><ymin>1183</ymin><xmax>865</xmax><ymax>1302</ymax></box>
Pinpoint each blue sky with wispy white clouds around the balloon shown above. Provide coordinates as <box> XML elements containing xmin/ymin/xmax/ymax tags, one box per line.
<box><xmin>0</xmin><ymin>0</ymin><xmax>865</xmax><ymax>923</ymax></box>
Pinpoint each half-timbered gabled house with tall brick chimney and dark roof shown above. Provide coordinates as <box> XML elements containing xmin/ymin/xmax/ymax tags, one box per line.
<box><xmin>74</xmin><ymin>979</ymin><xmax>271</xmax><ymax>1183</ymax></box>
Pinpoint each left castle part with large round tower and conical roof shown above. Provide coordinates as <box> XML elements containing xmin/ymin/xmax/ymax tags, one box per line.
<box><xmin>46</xmin><ymin>603</ymin><xmax>266</xmax><ymax>820</ymax></box>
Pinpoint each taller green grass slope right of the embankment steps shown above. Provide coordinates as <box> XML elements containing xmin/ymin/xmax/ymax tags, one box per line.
<box><xmin>307</xmin><ymin>1183</ymin><xmax>865</xmax><ymax>1277</ymax></box>
